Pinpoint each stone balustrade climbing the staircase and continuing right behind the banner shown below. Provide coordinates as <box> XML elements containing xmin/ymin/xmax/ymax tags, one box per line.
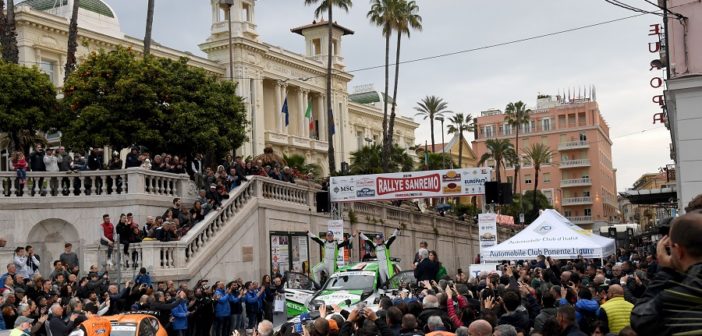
<box><xmin>114</xmin><ymin>176</ymin><xmax>511</xmax><ymax>276</ymax></box>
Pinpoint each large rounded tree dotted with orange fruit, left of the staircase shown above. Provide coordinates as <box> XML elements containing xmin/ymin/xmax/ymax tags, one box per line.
<box><xmin>63</xmin><ymin>48</ymin><xmax>247</xmax><ymax>157</ymax></box>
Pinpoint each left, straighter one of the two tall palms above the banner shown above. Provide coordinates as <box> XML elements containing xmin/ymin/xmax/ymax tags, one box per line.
<box><xmin>366</xmin><ymin>0</ymin><xmax>399</xmax><ymax>170</ymax></box>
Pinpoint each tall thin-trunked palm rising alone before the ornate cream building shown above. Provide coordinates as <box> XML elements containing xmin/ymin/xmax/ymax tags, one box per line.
<box><xmin>305</xmin><ymin>0</ymin><xmax>352</xmax><ymax>174</ymax></box>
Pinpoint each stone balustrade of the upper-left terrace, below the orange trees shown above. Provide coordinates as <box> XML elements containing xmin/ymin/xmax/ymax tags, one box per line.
<box><xmin>0</xmin><ymin>168</ymin><xmax>188</xmax><ymax>200</ymax></box>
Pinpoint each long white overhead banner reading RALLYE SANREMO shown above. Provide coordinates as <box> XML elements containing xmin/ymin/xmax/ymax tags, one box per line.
<box><xmin>329</xmin><ymin>168</ymin><xmax>492</xmax><ymax>202</ymax></box>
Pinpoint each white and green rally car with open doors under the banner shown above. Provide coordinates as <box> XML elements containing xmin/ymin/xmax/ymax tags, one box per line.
<box><xmin>285</xmin><ymin>261</ymin><xmax>416</xmax><ymax>318</ymax></box>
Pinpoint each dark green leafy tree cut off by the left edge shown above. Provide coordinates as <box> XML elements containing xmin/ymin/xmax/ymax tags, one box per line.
<box><xmin>0</xmin><ymin>61</ymin><xmax>57</xmax><ymax>152</ymax></box>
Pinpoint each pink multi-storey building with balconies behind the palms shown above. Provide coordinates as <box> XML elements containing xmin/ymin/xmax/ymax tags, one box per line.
<box><xmin>473</xmin><ymin>95</ymin><xmax>618</xmax><ymax>229</ymax></box>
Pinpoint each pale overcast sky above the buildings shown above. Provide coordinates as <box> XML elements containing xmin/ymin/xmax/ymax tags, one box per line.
<box><xmin>107</xmin><ymin>0</ymin><xmax>672</xmax><ymax>191</ymax></box>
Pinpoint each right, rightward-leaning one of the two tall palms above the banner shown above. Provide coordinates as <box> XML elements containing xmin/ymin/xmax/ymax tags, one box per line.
<box><xmin>384</xmin><ymin>0</ymin><xmax>424</xmax><ymax>165</ymax></box>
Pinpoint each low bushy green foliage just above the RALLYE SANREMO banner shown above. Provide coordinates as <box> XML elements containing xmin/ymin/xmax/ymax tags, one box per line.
<box><xmin>350</xmin><ymin>144</ymin><xmax>414</xmax><ymax>175</ymax></box>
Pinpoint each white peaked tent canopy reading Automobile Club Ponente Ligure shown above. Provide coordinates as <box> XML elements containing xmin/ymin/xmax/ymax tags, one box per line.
<box><xmin>481</xmin><ymin>210</ymin><xmax>615</xmax><ymax>261</ymax></box>
